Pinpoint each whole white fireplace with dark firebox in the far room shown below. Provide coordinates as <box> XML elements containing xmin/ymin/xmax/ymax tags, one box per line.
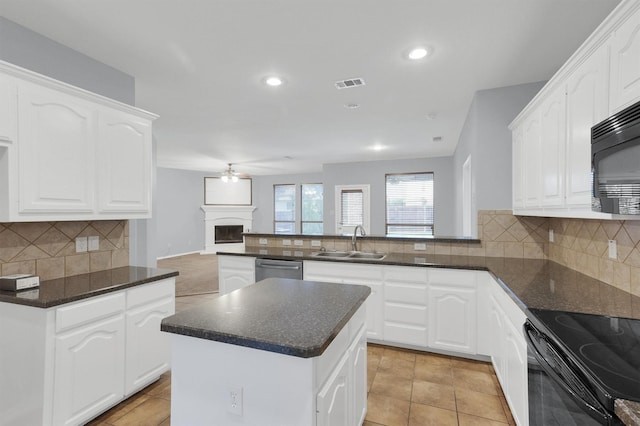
<box><xmin>201</xmin><ymin>205</ymin><xmax>256</xmax><ymax>253</ymax></box>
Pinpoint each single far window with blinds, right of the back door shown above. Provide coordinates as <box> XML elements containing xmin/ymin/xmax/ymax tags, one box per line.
<box><xmin>386</xmin><ymin>173</ymin><xmax>433</xmax><ymax>236</ymax></box>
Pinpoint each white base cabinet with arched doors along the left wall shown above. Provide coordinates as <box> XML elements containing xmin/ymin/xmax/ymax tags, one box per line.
<box><xmin>0</xmin><ymin>278</ymin><xmax>175</xmax><ymax>426</ymax></box>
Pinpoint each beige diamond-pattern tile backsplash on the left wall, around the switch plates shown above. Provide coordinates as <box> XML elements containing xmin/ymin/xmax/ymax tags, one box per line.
<box><xmin>0</xmin><ymin>220</ymin><xmax>129</xmax><ymax>280</ymax></box>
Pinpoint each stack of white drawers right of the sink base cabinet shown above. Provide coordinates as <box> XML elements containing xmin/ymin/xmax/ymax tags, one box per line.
<box><xmin>384</xmin><ymin>266</ymin><xmax>427</xmax><ymax>347</ymax></box>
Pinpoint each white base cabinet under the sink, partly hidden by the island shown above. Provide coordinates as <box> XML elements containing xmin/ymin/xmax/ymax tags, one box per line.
<box><xmin>302</xmin><ymin>260</ymin><xmax>384</xmax><ymax>340</ymax></box>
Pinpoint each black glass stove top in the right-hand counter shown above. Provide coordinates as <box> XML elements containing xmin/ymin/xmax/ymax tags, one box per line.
<box><xmin>530</xmin><ymin>309</ymin><xmax>640</xmax><ymax>405</ymax></box>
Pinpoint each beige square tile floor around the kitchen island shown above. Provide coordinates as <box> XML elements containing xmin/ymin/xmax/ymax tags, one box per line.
<box><xmin>89</xmin><ymin>294</ymin><xmax>515</xmax><ymax>426</ymax></box>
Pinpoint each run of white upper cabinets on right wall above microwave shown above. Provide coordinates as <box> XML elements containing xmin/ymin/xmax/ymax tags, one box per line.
<box><xmin>509</xmin><ymin>0</ymin><xmax>640</xmax><ymax>219</ymax></box>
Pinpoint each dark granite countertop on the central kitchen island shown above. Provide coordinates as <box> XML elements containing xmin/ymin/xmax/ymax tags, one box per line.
<box><xmin>161</xmin><ymin>278</ymin><xmax>371</xmax><ymax>358</ymax></box>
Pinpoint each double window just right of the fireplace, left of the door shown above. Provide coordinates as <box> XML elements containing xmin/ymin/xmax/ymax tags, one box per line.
<box><xmin>273</xmin><ymin>183</ymin><xmax>324</xmax><ymax>235</ymax></box>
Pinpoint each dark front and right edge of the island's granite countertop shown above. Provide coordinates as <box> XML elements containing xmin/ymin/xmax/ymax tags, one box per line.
<box><xmin>160</xmin><ymin>293</ymin><xmax>370</xmax><ymax>358</ymax></box>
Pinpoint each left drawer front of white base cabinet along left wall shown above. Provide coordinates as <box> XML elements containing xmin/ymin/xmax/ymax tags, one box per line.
<box><xmin>56</xmin><ymin>292</ymin><xmax>125</xmax><ymax>333</ymax></box>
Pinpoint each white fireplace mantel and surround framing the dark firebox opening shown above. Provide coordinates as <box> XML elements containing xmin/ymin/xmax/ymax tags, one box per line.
<box><xmin>200</xmin><ymin>205</ymin><xmax>256</xmax><ymax>253</ymax></box>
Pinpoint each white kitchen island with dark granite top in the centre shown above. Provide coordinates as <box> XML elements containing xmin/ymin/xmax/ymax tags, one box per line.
<box><xmin>161</xmin><ymin>278</ymin><xmax>370</xmax><ymax>425</ymax></box>
